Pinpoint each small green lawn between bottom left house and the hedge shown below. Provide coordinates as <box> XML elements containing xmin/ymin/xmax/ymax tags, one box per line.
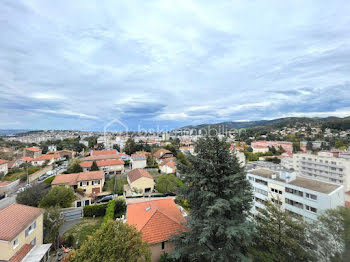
<box><xmin>63</xmin><ymin>217</ymin><xmax>103</xmax><ymax>248</ymax></box>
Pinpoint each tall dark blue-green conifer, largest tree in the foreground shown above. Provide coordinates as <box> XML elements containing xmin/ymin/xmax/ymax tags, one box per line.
<box><xmin>173</xmin><ymin>137</ymin><xmax>252</xmax><ymax>262</ymax></box>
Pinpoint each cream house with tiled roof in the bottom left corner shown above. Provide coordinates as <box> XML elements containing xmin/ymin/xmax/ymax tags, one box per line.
<box><xmin>0</xmin><ymin>203</ymin><xmax>51</xmax><ymax>262</ymax></box>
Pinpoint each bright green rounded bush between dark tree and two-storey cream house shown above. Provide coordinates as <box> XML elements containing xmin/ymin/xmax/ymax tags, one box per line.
<box><xmin>39</xmin><ymin>186</ymin><xmax>75</xmax><ymax>208</ymax></box>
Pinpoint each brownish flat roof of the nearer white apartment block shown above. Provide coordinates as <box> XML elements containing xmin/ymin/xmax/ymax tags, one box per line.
<box><xmin>248</xmin><ymin>168</ymin><xmax>341</xmax><ymax>194</ymax></box>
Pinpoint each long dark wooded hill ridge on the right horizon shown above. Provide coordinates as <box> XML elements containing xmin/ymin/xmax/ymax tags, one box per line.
<box><xmin>176</xmin><ymin>116</ymin><xmax>350</xmax><ymax>133</ymax></box>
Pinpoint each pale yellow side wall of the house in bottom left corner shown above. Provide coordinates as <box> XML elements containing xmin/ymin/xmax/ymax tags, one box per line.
<box><xmin>0</xmin><ymin>214</ymin><xmax>44</xmax><ymax>260</ymax></box>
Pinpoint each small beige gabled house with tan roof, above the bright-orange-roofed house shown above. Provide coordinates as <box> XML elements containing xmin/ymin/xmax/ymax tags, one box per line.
<box><xmin>125</xmin><ymin>168</ymin><xmax>154</xmax><ymax>194</ymax></box>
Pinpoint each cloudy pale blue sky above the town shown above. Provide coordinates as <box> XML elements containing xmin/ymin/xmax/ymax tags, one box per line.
<box><xmin>0</xmin><ymin>0</ymin><xmax>350</xmax><ymax>131</ymax></box>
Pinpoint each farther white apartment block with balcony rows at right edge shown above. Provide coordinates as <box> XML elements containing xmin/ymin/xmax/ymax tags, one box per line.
<box><xmin>293</xmin><ymin>152</ymin><xmax>350</xmax><ymax>191</ymax></box>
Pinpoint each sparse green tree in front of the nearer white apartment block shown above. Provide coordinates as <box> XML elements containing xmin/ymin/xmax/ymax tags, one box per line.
<box><xmin>249</xmin><ymin>202</ymin><xmax>316</xmax><ymax>262</ymax></box>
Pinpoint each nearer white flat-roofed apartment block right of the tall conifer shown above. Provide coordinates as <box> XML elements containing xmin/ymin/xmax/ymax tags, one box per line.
<box><xmin>247</xmin><ymin>169</ymin><xmax>344</xmax><ymax>220</ymax></box>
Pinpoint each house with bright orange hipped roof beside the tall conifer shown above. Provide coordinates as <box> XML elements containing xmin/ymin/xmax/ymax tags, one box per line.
<box><xmin>126</xmin><ymin>199</ymin><xmax>187</xmax><ymax>261</ymax></box>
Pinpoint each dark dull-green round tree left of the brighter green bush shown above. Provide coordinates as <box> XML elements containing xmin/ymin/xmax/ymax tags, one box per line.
<box><xmin>16</xmin><ymin>183</ymin><xmax>50</xmax><ymax>207</ymax></box>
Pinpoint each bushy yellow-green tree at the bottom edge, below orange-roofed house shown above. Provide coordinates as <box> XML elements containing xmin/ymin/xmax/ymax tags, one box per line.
<box><xmin>69</xmin><ymin>220</ymin><xmax>151</xmax><ymax>262</ymax></box>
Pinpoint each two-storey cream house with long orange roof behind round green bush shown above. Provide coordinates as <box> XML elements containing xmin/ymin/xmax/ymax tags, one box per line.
<box><xmin>51</xmin><ymin>170</ymin><xmax>105</xmax><ymax>207</ymax></box>
